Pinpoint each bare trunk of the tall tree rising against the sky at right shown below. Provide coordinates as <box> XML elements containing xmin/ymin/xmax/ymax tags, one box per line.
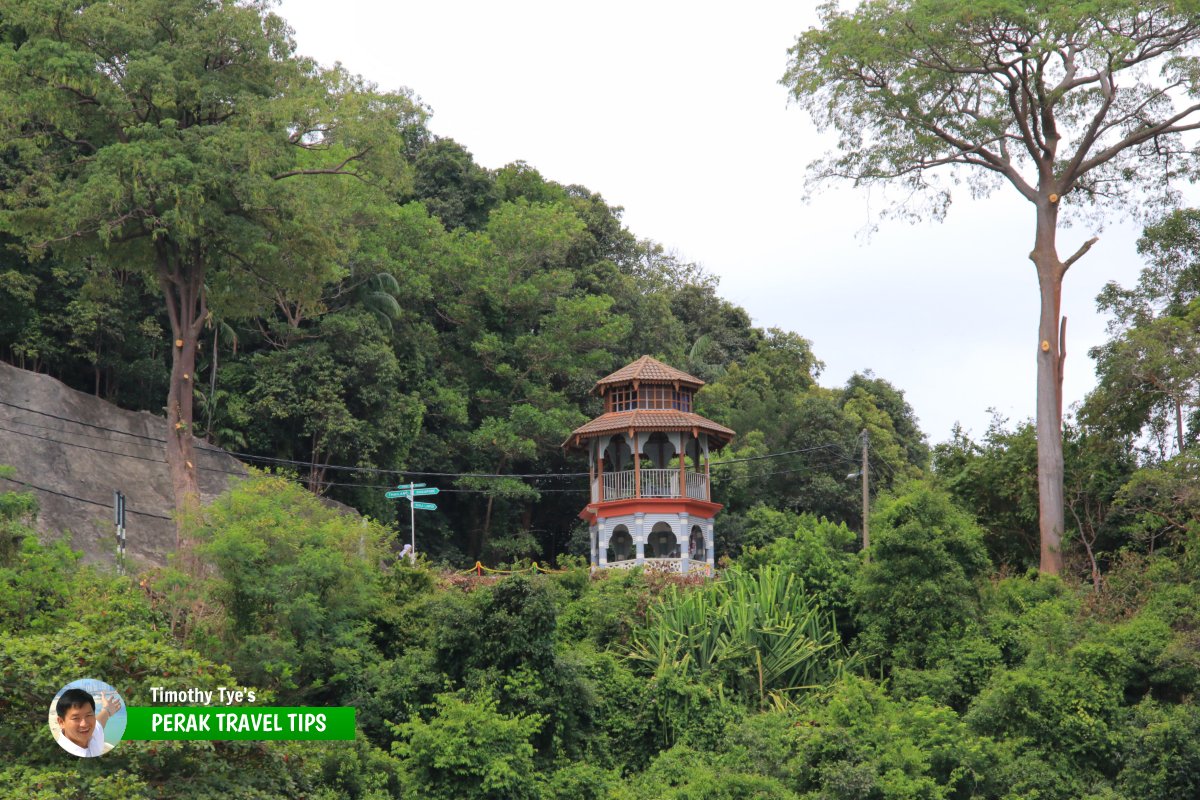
<box><xmin>1030</xmin><ymin>196</ymin><xmax>1067</xmax><ymax>575</ymax></box>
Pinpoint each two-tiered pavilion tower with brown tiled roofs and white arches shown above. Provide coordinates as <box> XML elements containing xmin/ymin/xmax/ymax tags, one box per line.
<box><xmin>563</xmin><ymin>355</ymin><xmax>733</xmax><ymax>575</ymax></box>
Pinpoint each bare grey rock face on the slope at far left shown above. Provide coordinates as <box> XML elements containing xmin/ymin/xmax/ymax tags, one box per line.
<box><xmin>0</xmin><ymin>362</ymin><xmax>246</xmax><ymax>566</ymax></box>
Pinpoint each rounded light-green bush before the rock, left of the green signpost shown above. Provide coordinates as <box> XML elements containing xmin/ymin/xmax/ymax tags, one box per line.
<box><xmin>199</xmin><ymin>477</ymin><xmax>385</xmax><ymax>705</ymax></box>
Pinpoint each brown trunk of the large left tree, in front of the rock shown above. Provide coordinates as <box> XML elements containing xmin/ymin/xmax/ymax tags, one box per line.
<box><xmin>158</xmin><ymin>243</ymin><xmax>208</xmax><ymax>563</ymax></box>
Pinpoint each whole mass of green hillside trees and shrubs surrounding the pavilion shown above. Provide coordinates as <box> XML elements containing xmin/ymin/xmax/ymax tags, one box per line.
<box><xmin>0</xmin><ymin>0</ymin><xmax>1200</xmax><ymax>800</ymax></box>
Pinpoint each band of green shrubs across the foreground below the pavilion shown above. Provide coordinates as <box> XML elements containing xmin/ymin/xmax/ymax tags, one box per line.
<box><xmin>0</xmin><ymin>477</ymin><xmax>1200</xmax><ymax>800</ymax></box>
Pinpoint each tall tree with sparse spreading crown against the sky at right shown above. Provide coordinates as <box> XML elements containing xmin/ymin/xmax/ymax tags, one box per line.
<box><xmin>784</xmin><ymin>0</ymin><xmax>1200</xmax><ymax>573</ymax></box>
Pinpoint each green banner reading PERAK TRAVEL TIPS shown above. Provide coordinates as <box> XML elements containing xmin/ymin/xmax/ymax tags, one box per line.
<box><xmin>124</xmin><ymin>705</ymin><xmax>354</xmax><ymax>741</ymax></box>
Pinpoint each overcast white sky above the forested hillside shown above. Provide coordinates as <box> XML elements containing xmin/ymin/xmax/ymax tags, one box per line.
<box><xmin>278</xmin><ymin>0</ymin><xmax>1140</xmax><ymax>443</ymax></box>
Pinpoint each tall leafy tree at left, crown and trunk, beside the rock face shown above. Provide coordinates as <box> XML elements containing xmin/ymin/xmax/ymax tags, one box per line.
<box><xmin>0</xmin><ymin>0</ymin><xmax>422</xmax><ymax>549</ymax></box>
